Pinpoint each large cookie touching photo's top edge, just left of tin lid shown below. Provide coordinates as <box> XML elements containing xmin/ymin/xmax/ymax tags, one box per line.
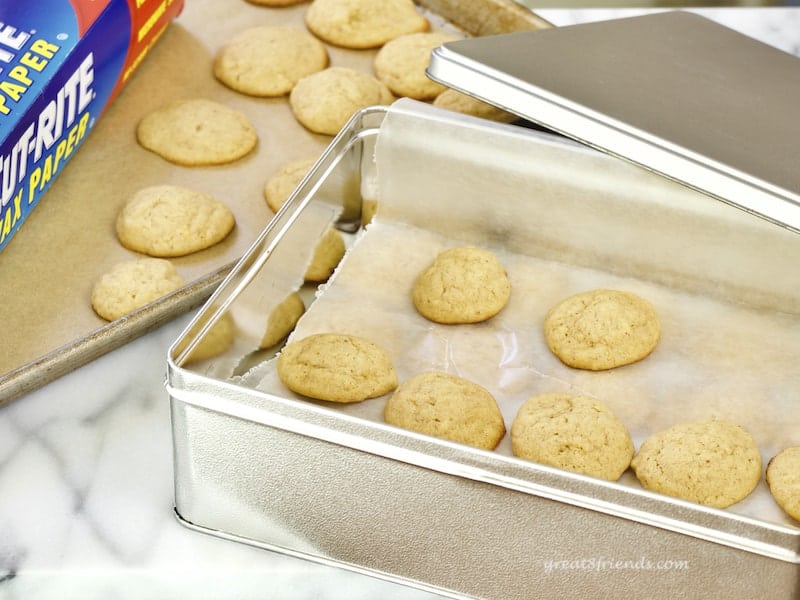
<box><xmin>305</xmin><ymin>0</ymin><xmax>430</xmax><ymax>49</ymax></box>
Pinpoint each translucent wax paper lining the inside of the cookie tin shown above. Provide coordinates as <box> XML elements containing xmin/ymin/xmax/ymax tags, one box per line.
<box><xmin>220</xmin><ymin>101</ymin><xmax>800</xmax><ymax>527</ymax></box>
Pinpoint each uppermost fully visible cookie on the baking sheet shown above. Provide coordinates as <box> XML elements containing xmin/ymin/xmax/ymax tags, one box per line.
<box><xmin>213</xmin><ymin>25</ymin><xmax>328</xmax><ymax>97</ymax></box>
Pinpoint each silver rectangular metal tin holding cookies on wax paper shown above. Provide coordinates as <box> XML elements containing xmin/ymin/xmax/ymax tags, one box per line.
<box><xmin>167</xmin><ymin>102</ymin><xmax>800</xmax><ymax>600</ymax></box>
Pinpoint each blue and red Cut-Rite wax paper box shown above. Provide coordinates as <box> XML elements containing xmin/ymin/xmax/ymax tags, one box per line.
<box><xmin>0</xmin><ymin>0</ymin><xmax>183</xmax><ymax>250</ymax></box>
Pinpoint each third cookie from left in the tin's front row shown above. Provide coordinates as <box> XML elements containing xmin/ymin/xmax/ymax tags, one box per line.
<box><xmin>511</xmin><ymin>393</ymin><xmax>633</xmax><ymax>481</ymax></box>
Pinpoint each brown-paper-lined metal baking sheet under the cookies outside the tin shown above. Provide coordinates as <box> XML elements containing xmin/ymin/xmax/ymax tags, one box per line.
<box><xmin>0</xmin><ymin>0</ymin><xmax>547</xmax><ymax>406</ymax></box>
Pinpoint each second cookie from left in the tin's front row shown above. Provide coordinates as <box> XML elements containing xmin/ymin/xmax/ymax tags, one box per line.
<box><xmin>383</xmin><ymin>371</ymin><xmax>506</xmax><ymax>450</ymax></box>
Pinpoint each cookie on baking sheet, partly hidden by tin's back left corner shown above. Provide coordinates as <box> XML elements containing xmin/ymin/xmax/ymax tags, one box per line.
<box><xmin>289</xmin><ymin>67</ymin><xmax>394</xmax><ymax>135</ymax></box>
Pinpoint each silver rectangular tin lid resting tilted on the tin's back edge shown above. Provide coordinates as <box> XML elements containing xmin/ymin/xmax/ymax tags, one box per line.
<box><xmin>428</xmin><ymin>11</ymin><xmax>800</xmax><ymax>232</ymax></box>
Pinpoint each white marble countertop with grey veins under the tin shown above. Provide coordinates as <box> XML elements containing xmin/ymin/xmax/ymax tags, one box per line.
<box><xmin>0</xmin><ymin>9</ymin><xmax>800</xmax><ymax>600</ymax></box>
